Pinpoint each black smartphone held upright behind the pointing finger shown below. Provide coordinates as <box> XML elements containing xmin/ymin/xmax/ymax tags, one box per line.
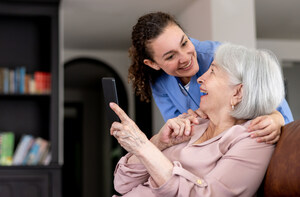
<box><xmin>102</xmin><ymin>77</ymin><xmax>120</xmax><ymax>125</ymax></box>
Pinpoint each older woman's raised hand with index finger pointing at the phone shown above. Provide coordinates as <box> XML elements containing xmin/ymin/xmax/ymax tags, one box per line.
<box><xmin>110</xmin><ymin>103</ymin><xmax>148</xmax><ymax>155</ymax></box>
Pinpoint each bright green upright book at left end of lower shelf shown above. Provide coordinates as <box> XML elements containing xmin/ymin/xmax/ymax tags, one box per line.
<box><xmin>0</xmin><ymin>132</ymin><xmax>15</xmax><ymax>166</ymax></box>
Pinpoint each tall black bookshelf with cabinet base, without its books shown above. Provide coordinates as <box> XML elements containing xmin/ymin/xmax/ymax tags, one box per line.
<box><xmin>0</xmin><ymin>0</ymin><xmax>61</xmax><ymax>197</ymax></box>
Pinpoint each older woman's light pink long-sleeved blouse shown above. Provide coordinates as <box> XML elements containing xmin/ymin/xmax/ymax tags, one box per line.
<box><xmin>114</xmin><ymin>121</ymin><xmax>274</xmax><ymax>197</ymax></box>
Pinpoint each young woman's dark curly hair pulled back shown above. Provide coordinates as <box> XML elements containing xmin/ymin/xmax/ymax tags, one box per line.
<box><xmin>128</xmin><ymin>12</ymin><xmax>180</xmax><ymax>102</ymax></box>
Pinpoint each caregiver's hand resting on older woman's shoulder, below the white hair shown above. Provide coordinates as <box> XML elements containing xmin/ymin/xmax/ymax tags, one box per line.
<box><xmin>248</xmin><ymin>111</ymin><xmax>284</xmax><ymax>144</ymax></box>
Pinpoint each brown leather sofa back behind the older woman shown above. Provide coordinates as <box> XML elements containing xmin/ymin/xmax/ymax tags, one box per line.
<box><xmin>257</xmin><ymin>120</ymin><xmax>300</xmax><ymax>197</ymax></box>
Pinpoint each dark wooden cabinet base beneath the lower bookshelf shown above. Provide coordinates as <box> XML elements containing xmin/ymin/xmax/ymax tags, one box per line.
<box><xmin>0</xmin><ymin>165</ymin><xmax>61</xmax><ymax>197</ymax></box>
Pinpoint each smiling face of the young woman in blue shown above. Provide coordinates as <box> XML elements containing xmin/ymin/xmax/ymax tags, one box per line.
<box><xmin>148</xmin><ymin>24</ymin><xmax>199</xmax><ymax>80</ymax></box>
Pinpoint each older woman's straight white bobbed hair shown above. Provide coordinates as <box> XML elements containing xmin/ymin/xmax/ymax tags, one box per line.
<box><xmin>215</xmin><ymin>43</ymin><xmax>284</xmax><ymax>119</ymax></box>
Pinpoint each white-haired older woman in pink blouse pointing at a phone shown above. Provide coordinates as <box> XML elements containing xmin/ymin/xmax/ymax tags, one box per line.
<box><xmin>110</xmin><ymin>44</ymin><xmax>284</xmax><ymax>197</ymax></box>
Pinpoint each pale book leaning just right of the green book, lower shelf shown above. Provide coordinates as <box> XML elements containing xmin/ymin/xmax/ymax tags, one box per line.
<box><xmin>12</xmin><ymin>135</ymin><xmax>34</xmax><ymax>165</ymax></box>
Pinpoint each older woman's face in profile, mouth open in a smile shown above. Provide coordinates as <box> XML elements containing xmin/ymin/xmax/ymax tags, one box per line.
<box><xmin>197</xmin><ymin>61</ymin><xmax>234</xmax><ymax>116</ymax></box>
